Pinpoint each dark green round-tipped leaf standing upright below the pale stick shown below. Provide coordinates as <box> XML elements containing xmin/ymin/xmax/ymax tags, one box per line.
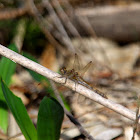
<box><xmin>37</xmin><ymin>97</ymin><xmax>64</xmax><ymax>140</ymax></box>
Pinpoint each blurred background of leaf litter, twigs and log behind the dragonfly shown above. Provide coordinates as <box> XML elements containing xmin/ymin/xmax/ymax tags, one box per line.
<box><xmin>0</xmin><ymin>0</ymin><xmax>140</xmax><ymax>140</ymax></box>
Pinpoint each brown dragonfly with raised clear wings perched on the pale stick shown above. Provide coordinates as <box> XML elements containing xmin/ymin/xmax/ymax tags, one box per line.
<box><xmin>60</xmin><ymin>54</ymin><xmax>107</xmax><ymax>99</ymax></box>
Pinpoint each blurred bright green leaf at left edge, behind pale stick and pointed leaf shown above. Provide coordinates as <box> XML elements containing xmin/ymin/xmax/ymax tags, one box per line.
<box><xmin>0</xmin><ymin>44</ymin><xmax>18</xmax><ymax>133</ymax></box>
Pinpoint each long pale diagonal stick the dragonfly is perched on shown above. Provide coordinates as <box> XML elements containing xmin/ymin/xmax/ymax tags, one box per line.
<box><xmin>0</xmin><ymin>45</ymin><xmax>136</xmax><ymax>120</ymax></box>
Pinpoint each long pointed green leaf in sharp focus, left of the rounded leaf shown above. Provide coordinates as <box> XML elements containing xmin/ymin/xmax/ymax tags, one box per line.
<box><xmin>1</xmin><ymin>80</ymin><xmax>37</xmax><ymax>140</ymax></box>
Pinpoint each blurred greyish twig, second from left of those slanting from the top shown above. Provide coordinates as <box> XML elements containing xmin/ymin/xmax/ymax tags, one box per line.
<box><xmin>43</xmin><ymin>0</ymin><xmax>75</xmax><ymax>53</ymax></box>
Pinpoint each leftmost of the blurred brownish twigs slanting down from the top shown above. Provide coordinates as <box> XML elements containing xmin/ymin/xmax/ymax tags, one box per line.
<box><xmin>27</xmin><ymin>0</ymin><xmax>67</xmax><ymax>56</ymax></box>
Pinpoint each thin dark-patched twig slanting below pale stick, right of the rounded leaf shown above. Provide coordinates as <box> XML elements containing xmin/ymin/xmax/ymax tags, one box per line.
<box><xmin>50</xmin><ymin>80</ymin><xmax>94</xmax><ymax>140</ymax></box>
